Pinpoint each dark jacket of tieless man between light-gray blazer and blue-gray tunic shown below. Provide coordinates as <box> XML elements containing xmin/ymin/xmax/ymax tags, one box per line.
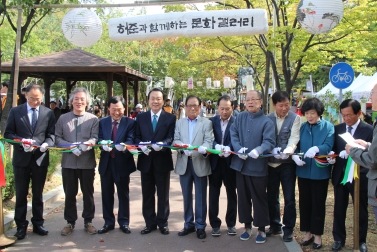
<box><xmin>209</xmin><ymin>115</ymin><xmax>234</xmax><ymax>170</ymax></box>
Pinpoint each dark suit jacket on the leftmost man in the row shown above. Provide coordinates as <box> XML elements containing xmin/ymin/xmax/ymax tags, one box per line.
<box><xmin>4</xmin><ymin>103</ymin><xmax>55</xmax><ymax>167</ymax></box>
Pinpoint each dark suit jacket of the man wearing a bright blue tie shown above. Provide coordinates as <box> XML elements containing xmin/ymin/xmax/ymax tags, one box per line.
<box><xmin>135</xmin><ymin>110</ymin><xmax>176</xmax><ymax>172</ymax></box>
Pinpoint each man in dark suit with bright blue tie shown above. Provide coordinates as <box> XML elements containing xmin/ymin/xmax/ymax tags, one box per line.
<box><xmin>135</xmin><ymin>88</ymin><xmax>176</xmax><ymax>235</ymax></box>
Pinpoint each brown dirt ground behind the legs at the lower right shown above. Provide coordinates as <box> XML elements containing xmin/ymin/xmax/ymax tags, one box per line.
<box><xmin>294</xmin><ymin>182</ymin><xmax>377</xmax><ymax>252</ymax></box>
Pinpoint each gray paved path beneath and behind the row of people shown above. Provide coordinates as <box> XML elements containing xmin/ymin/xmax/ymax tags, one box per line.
<box><xmin>3</xmin><ymin>153</ymin><xmax>302</xmax><ymax>252</ymax></box>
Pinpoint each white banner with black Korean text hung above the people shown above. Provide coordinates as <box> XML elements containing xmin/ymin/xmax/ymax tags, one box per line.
<box><xmin>108</xmin><ymin>9</ymin><xmax>268</xmax><ymax>41</ymax></box>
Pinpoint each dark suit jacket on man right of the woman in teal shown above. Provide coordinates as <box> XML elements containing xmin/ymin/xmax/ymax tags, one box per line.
<box><xmin>331</xmin><ymin>120</ymin><xmax>373</xmax><ymax>186</ymax></box>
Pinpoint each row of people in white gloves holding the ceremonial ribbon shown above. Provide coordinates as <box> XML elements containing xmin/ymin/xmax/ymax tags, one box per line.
<box><xmin>4</xmin><ymin>85</ymin><xmax>377</xmax><ymax>251</ymax></box>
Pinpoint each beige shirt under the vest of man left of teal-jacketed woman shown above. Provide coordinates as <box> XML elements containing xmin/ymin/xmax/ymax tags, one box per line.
<box><xmin>268</xmin><ymin>112</ymin><xmax>301</xmax><ymax>167</ymax></box>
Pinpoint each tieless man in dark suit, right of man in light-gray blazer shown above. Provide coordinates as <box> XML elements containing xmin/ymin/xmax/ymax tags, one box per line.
<box><xmin>208</xmin><ymin>95</ymin><xmax>237</xmax><ymax>236</ymax></box>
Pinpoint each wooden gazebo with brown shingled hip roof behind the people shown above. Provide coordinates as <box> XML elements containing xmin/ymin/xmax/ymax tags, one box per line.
<box><xmin>1</xmin><ymin>49</ymin><xmax>148</xmax><ymax>111</ymax></box>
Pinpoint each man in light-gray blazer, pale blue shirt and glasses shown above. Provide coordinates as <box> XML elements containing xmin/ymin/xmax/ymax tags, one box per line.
<box><xmin>173</xmin><ymin>95</ymin><xmax>214</xmax><ymax>239</ymax></box>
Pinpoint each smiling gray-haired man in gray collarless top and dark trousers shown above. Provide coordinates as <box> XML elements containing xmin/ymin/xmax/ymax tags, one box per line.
<box><xmin>55</xmin><ymin>88</ymin><xmax>99</xmax><ymax>235</ymax></box>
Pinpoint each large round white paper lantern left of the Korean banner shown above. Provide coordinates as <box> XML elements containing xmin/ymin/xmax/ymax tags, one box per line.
<box><xmin>62</xmin><ymin>9</ymin><xmax>102</xmax><ymax>47</ymax></box>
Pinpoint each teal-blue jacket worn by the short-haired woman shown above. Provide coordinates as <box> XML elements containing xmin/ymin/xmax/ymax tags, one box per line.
<box><xmin>296</xmin><ymin>119</ymin><xmax>335</xmax><ymax>180</ymax></box>
